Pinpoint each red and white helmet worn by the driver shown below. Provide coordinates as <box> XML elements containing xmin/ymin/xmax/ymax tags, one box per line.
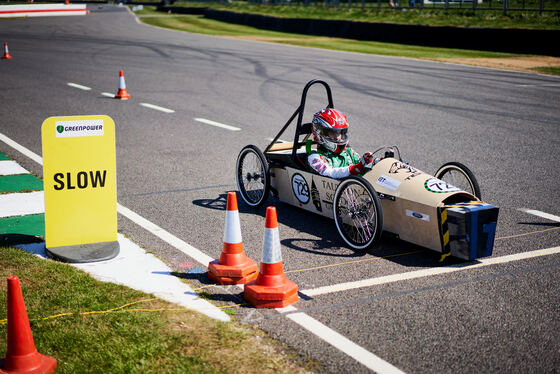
<box><xmin>312</xmin><ymin>108</ymin><xmax>348</xmax><ymax>153</ymax></box>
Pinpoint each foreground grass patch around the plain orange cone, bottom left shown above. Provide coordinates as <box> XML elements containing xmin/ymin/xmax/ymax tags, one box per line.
<box><xmin>0</xmin><ymin>248</ymin><xmax>312</xmax><ymax>373</ymax></box>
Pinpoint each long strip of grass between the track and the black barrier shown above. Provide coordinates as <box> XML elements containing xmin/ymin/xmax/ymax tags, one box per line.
<box><xmin>137</xmin><ymin>6</ymin><xmax>560</xmax><ymax>74</ymax></box>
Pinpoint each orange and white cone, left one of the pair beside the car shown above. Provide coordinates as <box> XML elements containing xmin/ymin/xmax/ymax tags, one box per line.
<box><xmin>208</xmin><ymin>192</ymin><xmax>259</xmax><ymax>284</ymax></box>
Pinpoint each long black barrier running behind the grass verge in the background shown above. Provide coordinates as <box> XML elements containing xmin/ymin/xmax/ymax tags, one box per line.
<box><xmin>204</xmin><ymin>8</ymin><xmax>560</xmax><ymax>56</ymax></box>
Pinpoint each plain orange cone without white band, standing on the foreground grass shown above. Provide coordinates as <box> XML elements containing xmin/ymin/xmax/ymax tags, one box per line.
<box><xmin>0</xmin><ymin>276</ymin><xmax>56</xmax><ymax>374</ymax></box>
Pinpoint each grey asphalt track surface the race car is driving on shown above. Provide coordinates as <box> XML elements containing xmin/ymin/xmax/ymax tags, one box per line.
<box><xmin>0</xmin><ymin>7</ymin><xmax>560</xmax><ymax>373</ymax></box>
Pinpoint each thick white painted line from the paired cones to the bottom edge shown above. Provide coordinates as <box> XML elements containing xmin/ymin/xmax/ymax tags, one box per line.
<box><xmin>282</xmin><ymin>306</ymin><xmax>404</xmax><ymax>374</ymax></box>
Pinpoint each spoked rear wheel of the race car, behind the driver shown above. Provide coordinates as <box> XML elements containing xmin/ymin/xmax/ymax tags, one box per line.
<box><xmin>235</xmin><ymin>145</ymin><xmax>270</xmax><ymax>207</ymax></box>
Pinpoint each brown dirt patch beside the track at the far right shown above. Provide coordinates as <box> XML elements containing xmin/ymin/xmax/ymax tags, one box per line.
<box><xmin>436</xmin><ymin>56</ymin><xmax>560</xmax><ymax>73</ymax></box>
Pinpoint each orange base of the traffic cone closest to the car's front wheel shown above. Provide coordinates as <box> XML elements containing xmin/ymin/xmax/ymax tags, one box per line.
<box><xmin>243</xmin><ymin>279</ymin><xmax>299</xmax><ymax>308</ymax></box>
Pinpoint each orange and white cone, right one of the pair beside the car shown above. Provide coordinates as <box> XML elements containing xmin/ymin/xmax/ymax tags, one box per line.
<box><xmin>244</xmin><ymin>207</ymin><xmax>299</xmax><ymax>308</ymax></box>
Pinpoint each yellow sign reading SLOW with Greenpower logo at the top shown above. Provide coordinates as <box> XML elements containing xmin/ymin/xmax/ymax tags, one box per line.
<box><xmin>41</xmin><ymin>115</ymin><xmax>118</xmax><ymax>254</ymax></box>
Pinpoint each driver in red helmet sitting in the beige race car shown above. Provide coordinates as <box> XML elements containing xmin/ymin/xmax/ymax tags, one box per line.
<box><xmin>307</xmin><ymin>108</ymin><xmax>379</xmax><ymax>179</ymax></box>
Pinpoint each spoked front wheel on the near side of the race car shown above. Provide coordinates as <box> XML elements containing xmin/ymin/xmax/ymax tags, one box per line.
<box><xmin>333</xmin><ymin>177</ymin><xmax>383</xmax><ymax>250</ymax></box>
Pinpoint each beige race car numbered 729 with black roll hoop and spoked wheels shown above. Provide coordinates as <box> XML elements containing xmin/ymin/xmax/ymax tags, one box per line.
<box><xmin>236</xmin><ymin>80</ymin><xmax>498</xmax><ymax>260</ymax></box>
